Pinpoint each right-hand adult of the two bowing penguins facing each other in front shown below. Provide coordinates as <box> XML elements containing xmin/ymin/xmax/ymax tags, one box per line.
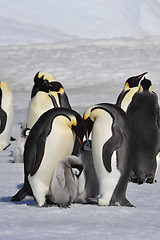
<box><xmin>84</xmin><ymin>103</ymin><xmax>133</xmax><ymax>207</ymax></box>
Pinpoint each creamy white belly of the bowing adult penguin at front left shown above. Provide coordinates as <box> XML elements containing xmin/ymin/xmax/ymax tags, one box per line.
<box><xmin>28</xmin><ymin>117</ymin><xmax>75</xmax><ymax>207</ymax></box>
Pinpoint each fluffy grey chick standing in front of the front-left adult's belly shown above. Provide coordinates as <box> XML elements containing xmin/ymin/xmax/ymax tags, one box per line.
<box><xmin>50</xmin><ymin>156</ymin><xmax>83</xmax><ymax>207</ymax></box>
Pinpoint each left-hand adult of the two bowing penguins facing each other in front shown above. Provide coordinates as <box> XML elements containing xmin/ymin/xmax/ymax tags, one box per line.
<box><xmin>11</xmin><ymin>108</ymin><xmax>84</xmax><ymax>207</ymax></box>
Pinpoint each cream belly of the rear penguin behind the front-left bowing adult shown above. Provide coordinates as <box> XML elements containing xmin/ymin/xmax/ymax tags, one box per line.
<box><xmin>27</xmin><ymin>92</ymin><xmax>54</xmax><ymax>128</ymax></box>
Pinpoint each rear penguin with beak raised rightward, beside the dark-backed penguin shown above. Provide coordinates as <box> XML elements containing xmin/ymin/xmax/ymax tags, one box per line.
<box><xmin>116</xmin><ymin>72</ymin><xmax>147</xmax><ymax>112</ymax></box>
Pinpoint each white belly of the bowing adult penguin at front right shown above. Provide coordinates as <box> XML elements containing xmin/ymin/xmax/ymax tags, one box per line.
<box><xmin>92</xmin><ymin>112</ymin><xmax>120</xmax><ymax>205</ymax></box>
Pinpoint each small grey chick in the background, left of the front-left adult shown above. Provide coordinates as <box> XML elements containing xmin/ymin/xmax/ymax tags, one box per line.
<box><xmin>13</xmin><ymin>124</ymin><xmax>30</xmax><ymax>163</ymax></box>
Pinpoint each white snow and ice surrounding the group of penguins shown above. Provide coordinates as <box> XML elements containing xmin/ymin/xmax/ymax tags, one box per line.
<box><xmin>0</xmin><ymin>0</ymin><xmax>160</xmax><ymax>240</ymax></box>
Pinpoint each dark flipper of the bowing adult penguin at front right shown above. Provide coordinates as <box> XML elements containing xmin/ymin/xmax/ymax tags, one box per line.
<box><xmin>102</xmin><ymin>131</ymin><xmax>123</xmax><ymax>172</ymax></box>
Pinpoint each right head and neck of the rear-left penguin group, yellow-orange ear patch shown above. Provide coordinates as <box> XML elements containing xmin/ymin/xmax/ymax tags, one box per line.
<box><xmin>49</xmin><ymin>81</ymin><xmax>71</xmax><ymax>109</ymax></box>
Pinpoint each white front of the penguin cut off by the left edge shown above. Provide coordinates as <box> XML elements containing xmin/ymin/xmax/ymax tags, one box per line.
<box><xmin>0</xmin><ymin>89</ymin><xmax>14</xmax><ymax>150</ymax></box>
